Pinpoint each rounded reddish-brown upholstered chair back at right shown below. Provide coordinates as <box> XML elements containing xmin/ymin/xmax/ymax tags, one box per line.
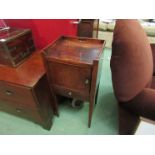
<box><xmin>111</xmin><ymin>20</ymin><xmax>155</xmax><ymax>101</ymax></box>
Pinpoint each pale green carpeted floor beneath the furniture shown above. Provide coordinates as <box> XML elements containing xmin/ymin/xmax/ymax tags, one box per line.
<box><xmin>0</xmin><ymin>49</ymin><xmax>118</xmax><ymax>135</ymax></box>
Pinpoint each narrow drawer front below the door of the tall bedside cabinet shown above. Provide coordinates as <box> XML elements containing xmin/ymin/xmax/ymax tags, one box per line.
<box><xmin>51</xmin><ymin>85</ymin><xmax>89</xmax><ymax>101</ymax></box>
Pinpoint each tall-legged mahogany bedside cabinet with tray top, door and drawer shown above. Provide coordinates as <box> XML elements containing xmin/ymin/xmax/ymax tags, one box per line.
<box><xmin>42</xmin><ymin>36</ymin><xmax>105</xmax><ymax>127</ymax></box>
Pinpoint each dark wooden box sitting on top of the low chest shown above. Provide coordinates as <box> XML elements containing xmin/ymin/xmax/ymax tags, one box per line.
<box><xmin>0</xmin><ymin>28</ymin><xmax>35</xmax><ymax>67</ymax></box>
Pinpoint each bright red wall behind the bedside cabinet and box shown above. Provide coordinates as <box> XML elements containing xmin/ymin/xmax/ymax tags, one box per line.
<box><xmin>5</xmin><ymin>19</ymin><xmax>77</xmax><ymax>49</ymax></box>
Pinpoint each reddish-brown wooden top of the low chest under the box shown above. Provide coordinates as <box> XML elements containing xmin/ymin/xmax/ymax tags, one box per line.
<box><xmin>0</xmin><ymin>51</ymin><xmax>45</xmax><ymax>87</ymax></box>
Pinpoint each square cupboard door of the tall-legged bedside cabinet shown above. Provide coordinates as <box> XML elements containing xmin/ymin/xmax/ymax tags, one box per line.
<box><xmin>48</xmin><ymin>62</ymin><xmax>91</xmax><ymax>93</ymax></box>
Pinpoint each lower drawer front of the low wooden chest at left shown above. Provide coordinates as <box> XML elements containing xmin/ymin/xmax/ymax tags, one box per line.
<box><xmin>0</xmin><ymin>100</ymin><xmax>42</xmax><ymax>123</ymax></box>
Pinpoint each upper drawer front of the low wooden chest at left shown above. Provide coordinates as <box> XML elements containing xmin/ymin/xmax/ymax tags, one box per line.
<box><xmin>0</xmin><ymin>81</ymin><xmax>36</xmax><ymax>108</ymax></box>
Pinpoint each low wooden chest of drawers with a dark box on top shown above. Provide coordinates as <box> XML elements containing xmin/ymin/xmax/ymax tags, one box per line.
<box><xmin>0</xmin><ymin>51</ymin><xmax>54</xmax><ymax>129</ymax></box>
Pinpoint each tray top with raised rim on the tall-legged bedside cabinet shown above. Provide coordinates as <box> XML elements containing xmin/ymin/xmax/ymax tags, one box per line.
<box><xmin>44</xmin><ymin>36</ymin><xmax>105</xmax><ymax>64</ymax></box>
